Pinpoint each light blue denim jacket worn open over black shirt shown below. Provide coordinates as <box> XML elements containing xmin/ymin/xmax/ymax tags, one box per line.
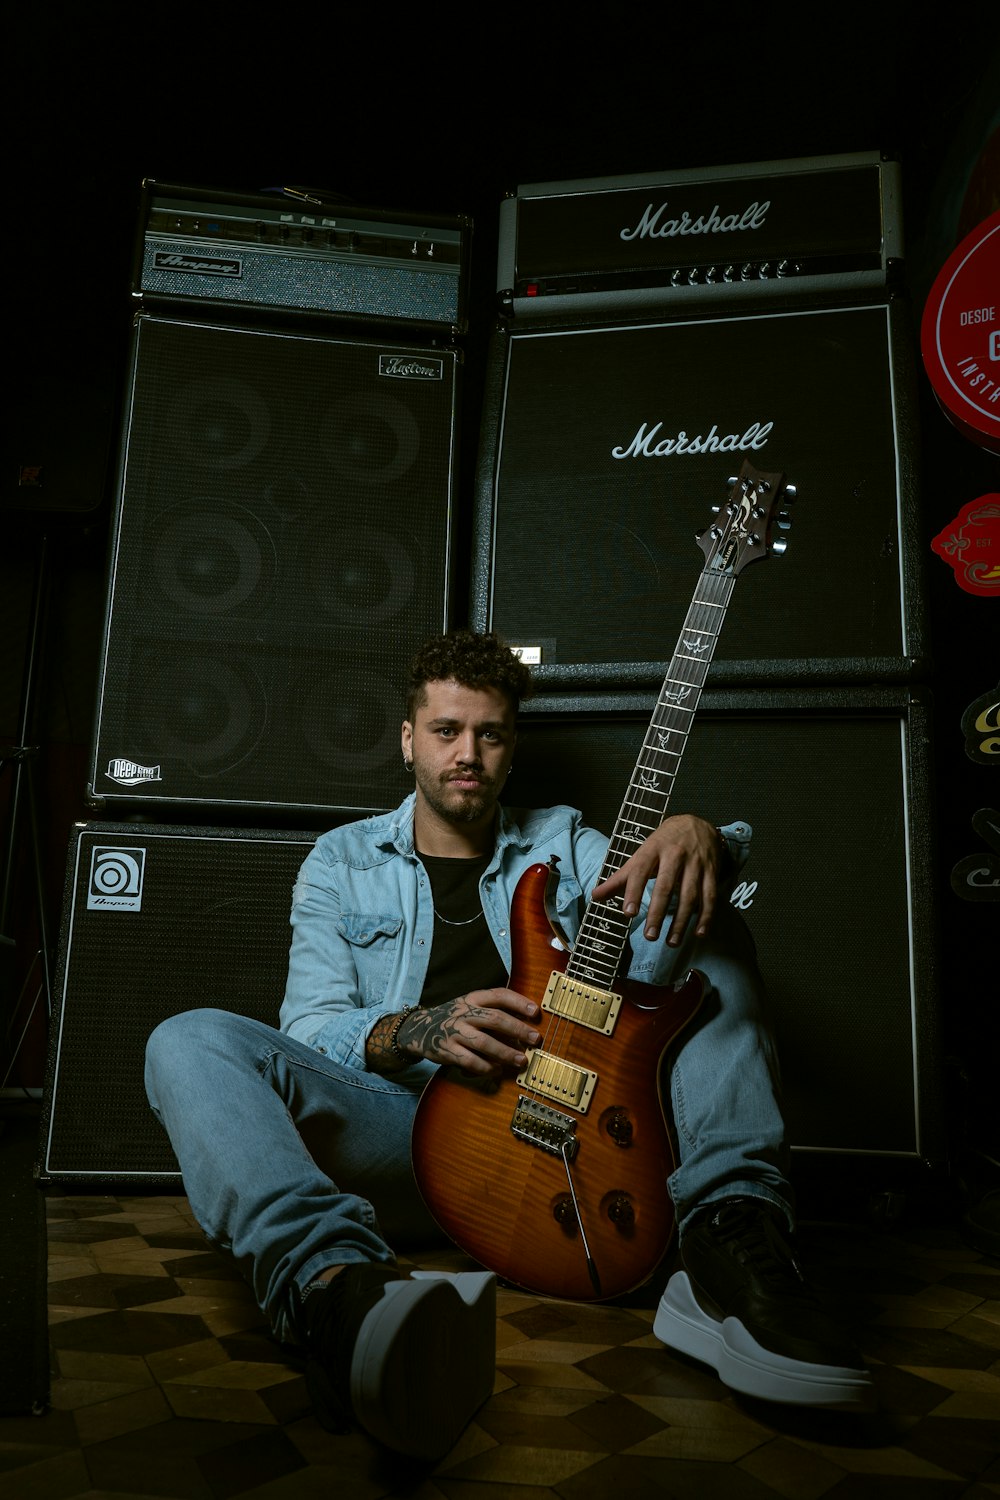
<box><xmin>280</xmin><ymin>794</ymin><xmax>751</xmax><ymax>1083</ymax></box>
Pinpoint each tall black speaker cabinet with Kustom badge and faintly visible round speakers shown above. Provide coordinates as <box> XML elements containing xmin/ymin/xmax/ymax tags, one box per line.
<box><xmin>88</xmin><ymin>314</ymin><xmax>459</xmax><ymax>821</ymax></box>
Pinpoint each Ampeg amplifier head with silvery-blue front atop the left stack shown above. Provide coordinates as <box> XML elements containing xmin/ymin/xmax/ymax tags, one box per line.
<box><xmin>132</xmin><ymin>179</ymin><xmax>472</xmax><ymax>335</ymax></box>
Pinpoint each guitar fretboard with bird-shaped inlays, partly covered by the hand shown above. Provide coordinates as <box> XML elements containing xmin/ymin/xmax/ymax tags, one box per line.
<box><xmin>567</xmin><ymin>567</ymin><xmax>736</xmax><ymax>989</ymax></box>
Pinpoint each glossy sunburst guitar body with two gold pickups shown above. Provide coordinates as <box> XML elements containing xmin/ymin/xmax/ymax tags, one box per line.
<box><xmin>414</xmin><ymin>864</ymin><xmax>702</xmax><ymax>1302</ymax></box>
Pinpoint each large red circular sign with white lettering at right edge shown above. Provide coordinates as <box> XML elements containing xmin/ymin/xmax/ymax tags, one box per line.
<box><xmin>921</xmin><ymin>212</ymin><xmax>1000</xmax><ymax>455</ymax></box>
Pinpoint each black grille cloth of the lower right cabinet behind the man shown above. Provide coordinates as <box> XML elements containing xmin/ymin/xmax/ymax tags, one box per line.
<box><xmin>505</xmin><ymin>714</ymin><xmax>925</xmax><ymax>1152</ymax></box>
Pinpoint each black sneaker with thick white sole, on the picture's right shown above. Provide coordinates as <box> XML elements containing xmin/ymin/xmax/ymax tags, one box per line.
<box><xmin>652</xmin><ymin>1199</ymin><xmax>873</xmax><ymax>1412</ymax></box>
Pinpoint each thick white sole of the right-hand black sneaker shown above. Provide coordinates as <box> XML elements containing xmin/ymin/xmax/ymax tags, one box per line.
<box><xmin>652</xmin><ymin>1271</ymin><xmax>874</xmax><ymax>1412</ymax></box>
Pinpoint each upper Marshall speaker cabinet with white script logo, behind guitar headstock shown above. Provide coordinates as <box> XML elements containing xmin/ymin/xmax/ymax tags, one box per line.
<box><xmin>471</xmin><ymin>301</ymin><xmax>927</xmax><ymax>690</ymax></box>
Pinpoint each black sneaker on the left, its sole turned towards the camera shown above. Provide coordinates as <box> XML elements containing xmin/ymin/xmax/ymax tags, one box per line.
<box><xmin>303</xmin><ymin>1263</ymin><xmax>496</xmax><ymax>1460</ymax></box>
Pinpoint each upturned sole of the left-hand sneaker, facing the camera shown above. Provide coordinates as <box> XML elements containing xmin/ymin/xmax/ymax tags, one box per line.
<box><xmin>351</xmin><ymin>1271</ymin><xmax>496</xmax><ymax>1460</ymax></box>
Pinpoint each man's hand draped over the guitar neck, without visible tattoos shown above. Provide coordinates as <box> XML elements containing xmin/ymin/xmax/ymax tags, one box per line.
<box><xmin>594</xmin><ymin>813</ymin><xmax>723</xmax><ymax>948</ymax></box>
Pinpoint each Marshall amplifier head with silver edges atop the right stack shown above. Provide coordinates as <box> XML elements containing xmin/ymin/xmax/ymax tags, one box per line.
<box><xmin>496</xmin><ymin>152</ymin><xmax>903</xmax><ymax>318</ymax></box>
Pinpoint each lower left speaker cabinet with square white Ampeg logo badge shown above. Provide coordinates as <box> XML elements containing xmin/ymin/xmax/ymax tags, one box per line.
<box><xmin>37</xmin><ymin>822</ymin><xmax>315</xmax><ymax>1187</ymax></box>
